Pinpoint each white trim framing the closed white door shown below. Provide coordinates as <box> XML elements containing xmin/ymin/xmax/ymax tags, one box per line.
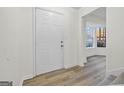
<box><xmin>32</xmin><ymin>7</ymin><xmax>65</xmax><ymax>77</ymax></box>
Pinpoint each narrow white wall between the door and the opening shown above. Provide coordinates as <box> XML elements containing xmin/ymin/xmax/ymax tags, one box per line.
<box><xmin>64</xmin><ymin>8</ymin><xmax>78</xmax><ymax>67</ymax></box>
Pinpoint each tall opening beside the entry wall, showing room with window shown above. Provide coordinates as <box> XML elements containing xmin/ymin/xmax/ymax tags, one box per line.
<box><xmin>82</xmin><ymin>7</ymin><xmax>106</xmax><ymax>82</ymax></box>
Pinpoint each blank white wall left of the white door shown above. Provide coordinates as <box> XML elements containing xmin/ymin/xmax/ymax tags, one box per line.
<box><xmin>0</xmin><ymin>8</ymin><xmax>33</xmax><ymax>85</ymax></box>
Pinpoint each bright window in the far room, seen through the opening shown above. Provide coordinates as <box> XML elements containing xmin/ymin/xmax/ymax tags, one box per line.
<box><xmin>86</xmin><ymin>23</ymin><xmax>106</xmax><ymax>48</ymax></box>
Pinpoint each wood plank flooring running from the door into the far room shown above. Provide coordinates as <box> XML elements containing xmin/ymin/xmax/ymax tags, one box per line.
<box><xmin>23</xmin><ymin>56</ymin><xmax>106</xmax><ymax>86</ymax></box>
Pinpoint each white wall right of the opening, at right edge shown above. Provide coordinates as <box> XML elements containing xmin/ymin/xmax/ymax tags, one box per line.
<box><xmin>106</xmin><ymin>8</ymin><xmax>124</xmax><ymax>72</ymax></box>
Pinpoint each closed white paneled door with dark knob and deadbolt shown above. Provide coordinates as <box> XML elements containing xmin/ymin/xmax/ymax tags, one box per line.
<box><xmin>36</xmin><ymin>8</ymin><xmax>64</xmax><ymax>75</ymax></box>
